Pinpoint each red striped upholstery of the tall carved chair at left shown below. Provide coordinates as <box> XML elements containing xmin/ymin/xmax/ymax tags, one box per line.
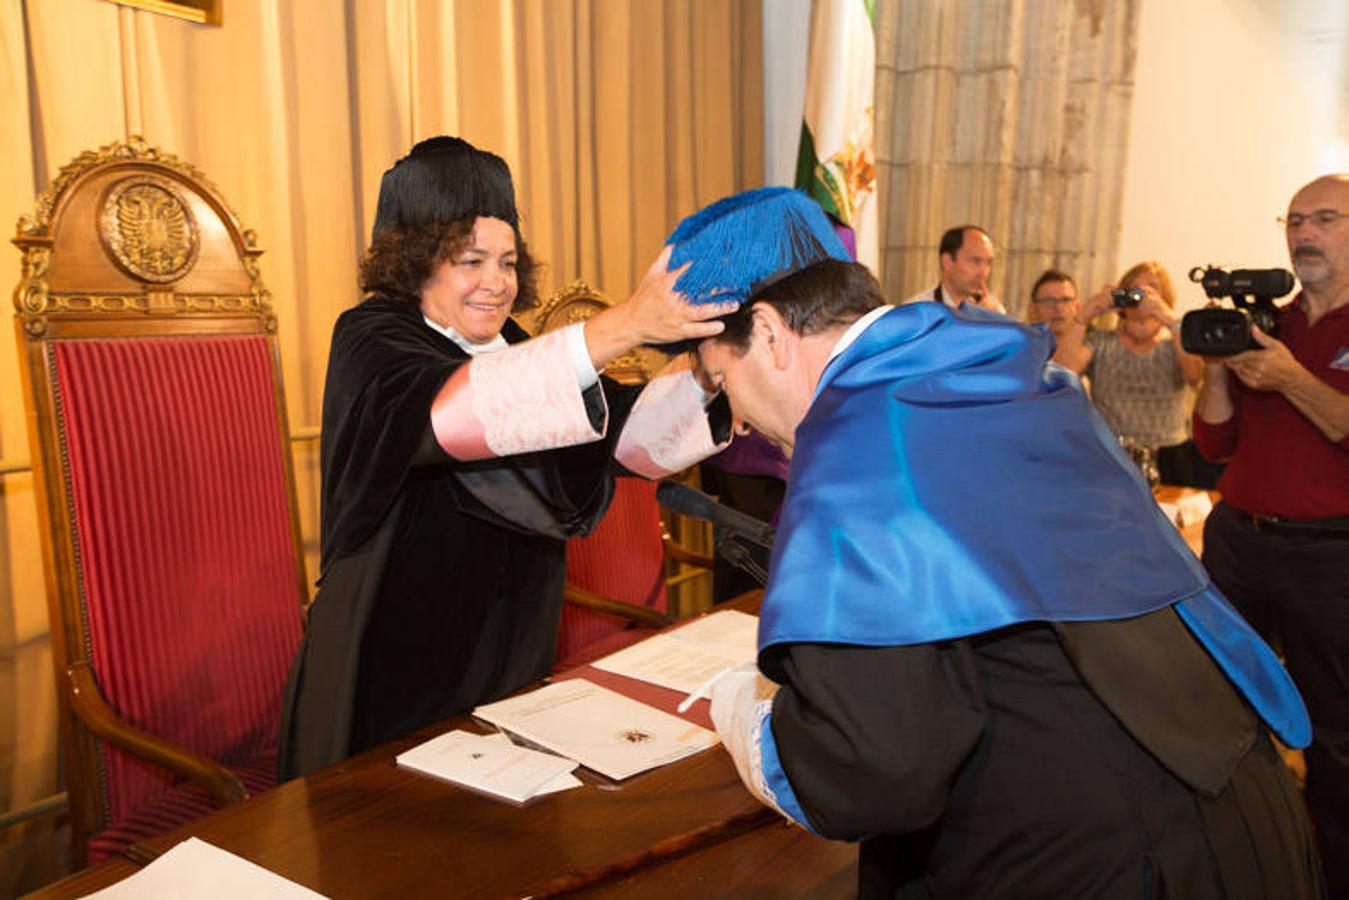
<box><xmin>53</xmin><ymin>336</ymin><xmax>301</xmax><ymax>820</ymax></box>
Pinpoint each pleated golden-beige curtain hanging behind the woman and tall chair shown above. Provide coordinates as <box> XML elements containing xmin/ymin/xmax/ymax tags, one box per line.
<box><xmin>0</xmin><ymin>0</ymin><xmax>762</xmax><ymax>893</ymax></box>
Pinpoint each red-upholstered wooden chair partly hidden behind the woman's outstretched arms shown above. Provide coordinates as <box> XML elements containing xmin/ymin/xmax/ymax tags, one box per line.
<box><xmin>534</xmin><ymin>281</ymin><xmax>712</xmax><ymax>668</ymax></box>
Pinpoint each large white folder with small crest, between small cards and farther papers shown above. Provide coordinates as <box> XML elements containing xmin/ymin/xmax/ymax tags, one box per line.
<box><xmin>473</xmin><ymin>679</ymin><xmax>718</xmax><ymax>781</ymax></box>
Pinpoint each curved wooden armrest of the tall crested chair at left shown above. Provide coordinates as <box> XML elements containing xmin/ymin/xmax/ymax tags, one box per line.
<box><xmin>66</xmin><ymin>663</ymin><xmax>248</xmax><ymax>807</ymax></box>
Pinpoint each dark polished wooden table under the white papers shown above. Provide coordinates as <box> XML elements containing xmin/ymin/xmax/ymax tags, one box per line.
<box><xmin>32</xmin><ymin>598</ymin><xmax>857</xmax><ymax>897</ymax></box>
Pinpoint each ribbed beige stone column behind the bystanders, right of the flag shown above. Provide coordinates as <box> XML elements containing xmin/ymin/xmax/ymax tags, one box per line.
<box><xmin>877</xmin><ymin>0</ymin><xmax>1140</xmax><ymax>314</ymax></box>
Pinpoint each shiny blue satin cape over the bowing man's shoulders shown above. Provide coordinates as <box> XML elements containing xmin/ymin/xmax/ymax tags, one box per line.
<box><xmin>758</xmin><ymin>304</ymin><xmax>1311</xmax><ymax>748</ymax></box>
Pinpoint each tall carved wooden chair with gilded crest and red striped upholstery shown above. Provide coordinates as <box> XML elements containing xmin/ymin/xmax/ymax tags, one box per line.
<box><xmin>13</xmin><ymin>139</ymin><xmax>305</xmax><ymax>862</ymax></box>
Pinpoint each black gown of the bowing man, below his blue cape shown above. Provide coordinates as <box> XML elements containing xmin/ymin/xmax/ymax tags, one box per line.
<box><xmin>761</xmin><ymin>609</ymin><xmax>1321</xmax><ymax>900</ymax></box>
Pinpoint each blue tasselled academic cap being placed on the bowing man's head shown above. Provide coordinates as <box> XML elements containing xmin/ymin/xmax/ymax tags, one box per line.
<box><xmin>665</xmin><ymin>188</ymin><xmax>853</xmax><ymax>305</ymax></box>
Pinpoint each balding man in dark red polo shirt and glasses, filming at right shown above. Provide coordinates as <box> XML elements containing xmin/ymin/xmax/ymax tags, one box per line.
<box><xmin>1194</xmin><ymin>174</ymin><xmax>1349</xmax><ymax>897</ymax></box>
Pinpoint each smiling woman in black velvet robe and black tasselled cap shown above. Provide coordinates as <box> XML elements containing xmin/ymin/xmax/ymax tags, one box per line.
<box><xmin>278</xmin><ymin>138</ymin><xmax>727</xmax><ymax>780</ymax></box>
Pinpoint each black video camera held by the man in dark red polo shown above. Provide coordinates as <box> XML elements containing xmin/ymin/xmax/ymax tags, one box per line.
<box><xmin>1180</xmin><ymin>266</ymin><xmax>1292</xmax><ymax>356</ymax></box>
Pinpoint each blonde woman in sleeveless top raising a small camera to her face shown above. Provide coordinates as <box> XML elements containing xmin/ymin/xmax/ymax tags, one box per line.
<box><xmin>1055</xmin><ymin>262</ymin><xmax>1203</xmax><ymax>484</ymax></box>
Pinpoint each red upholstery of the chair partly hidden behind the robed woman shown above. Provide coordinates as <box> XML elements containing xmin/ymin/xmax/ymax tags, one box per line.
<box><xmin>557</xmin><ymin>478</ymin><xmax>666</xmax><ymax>660</ymax></box>
